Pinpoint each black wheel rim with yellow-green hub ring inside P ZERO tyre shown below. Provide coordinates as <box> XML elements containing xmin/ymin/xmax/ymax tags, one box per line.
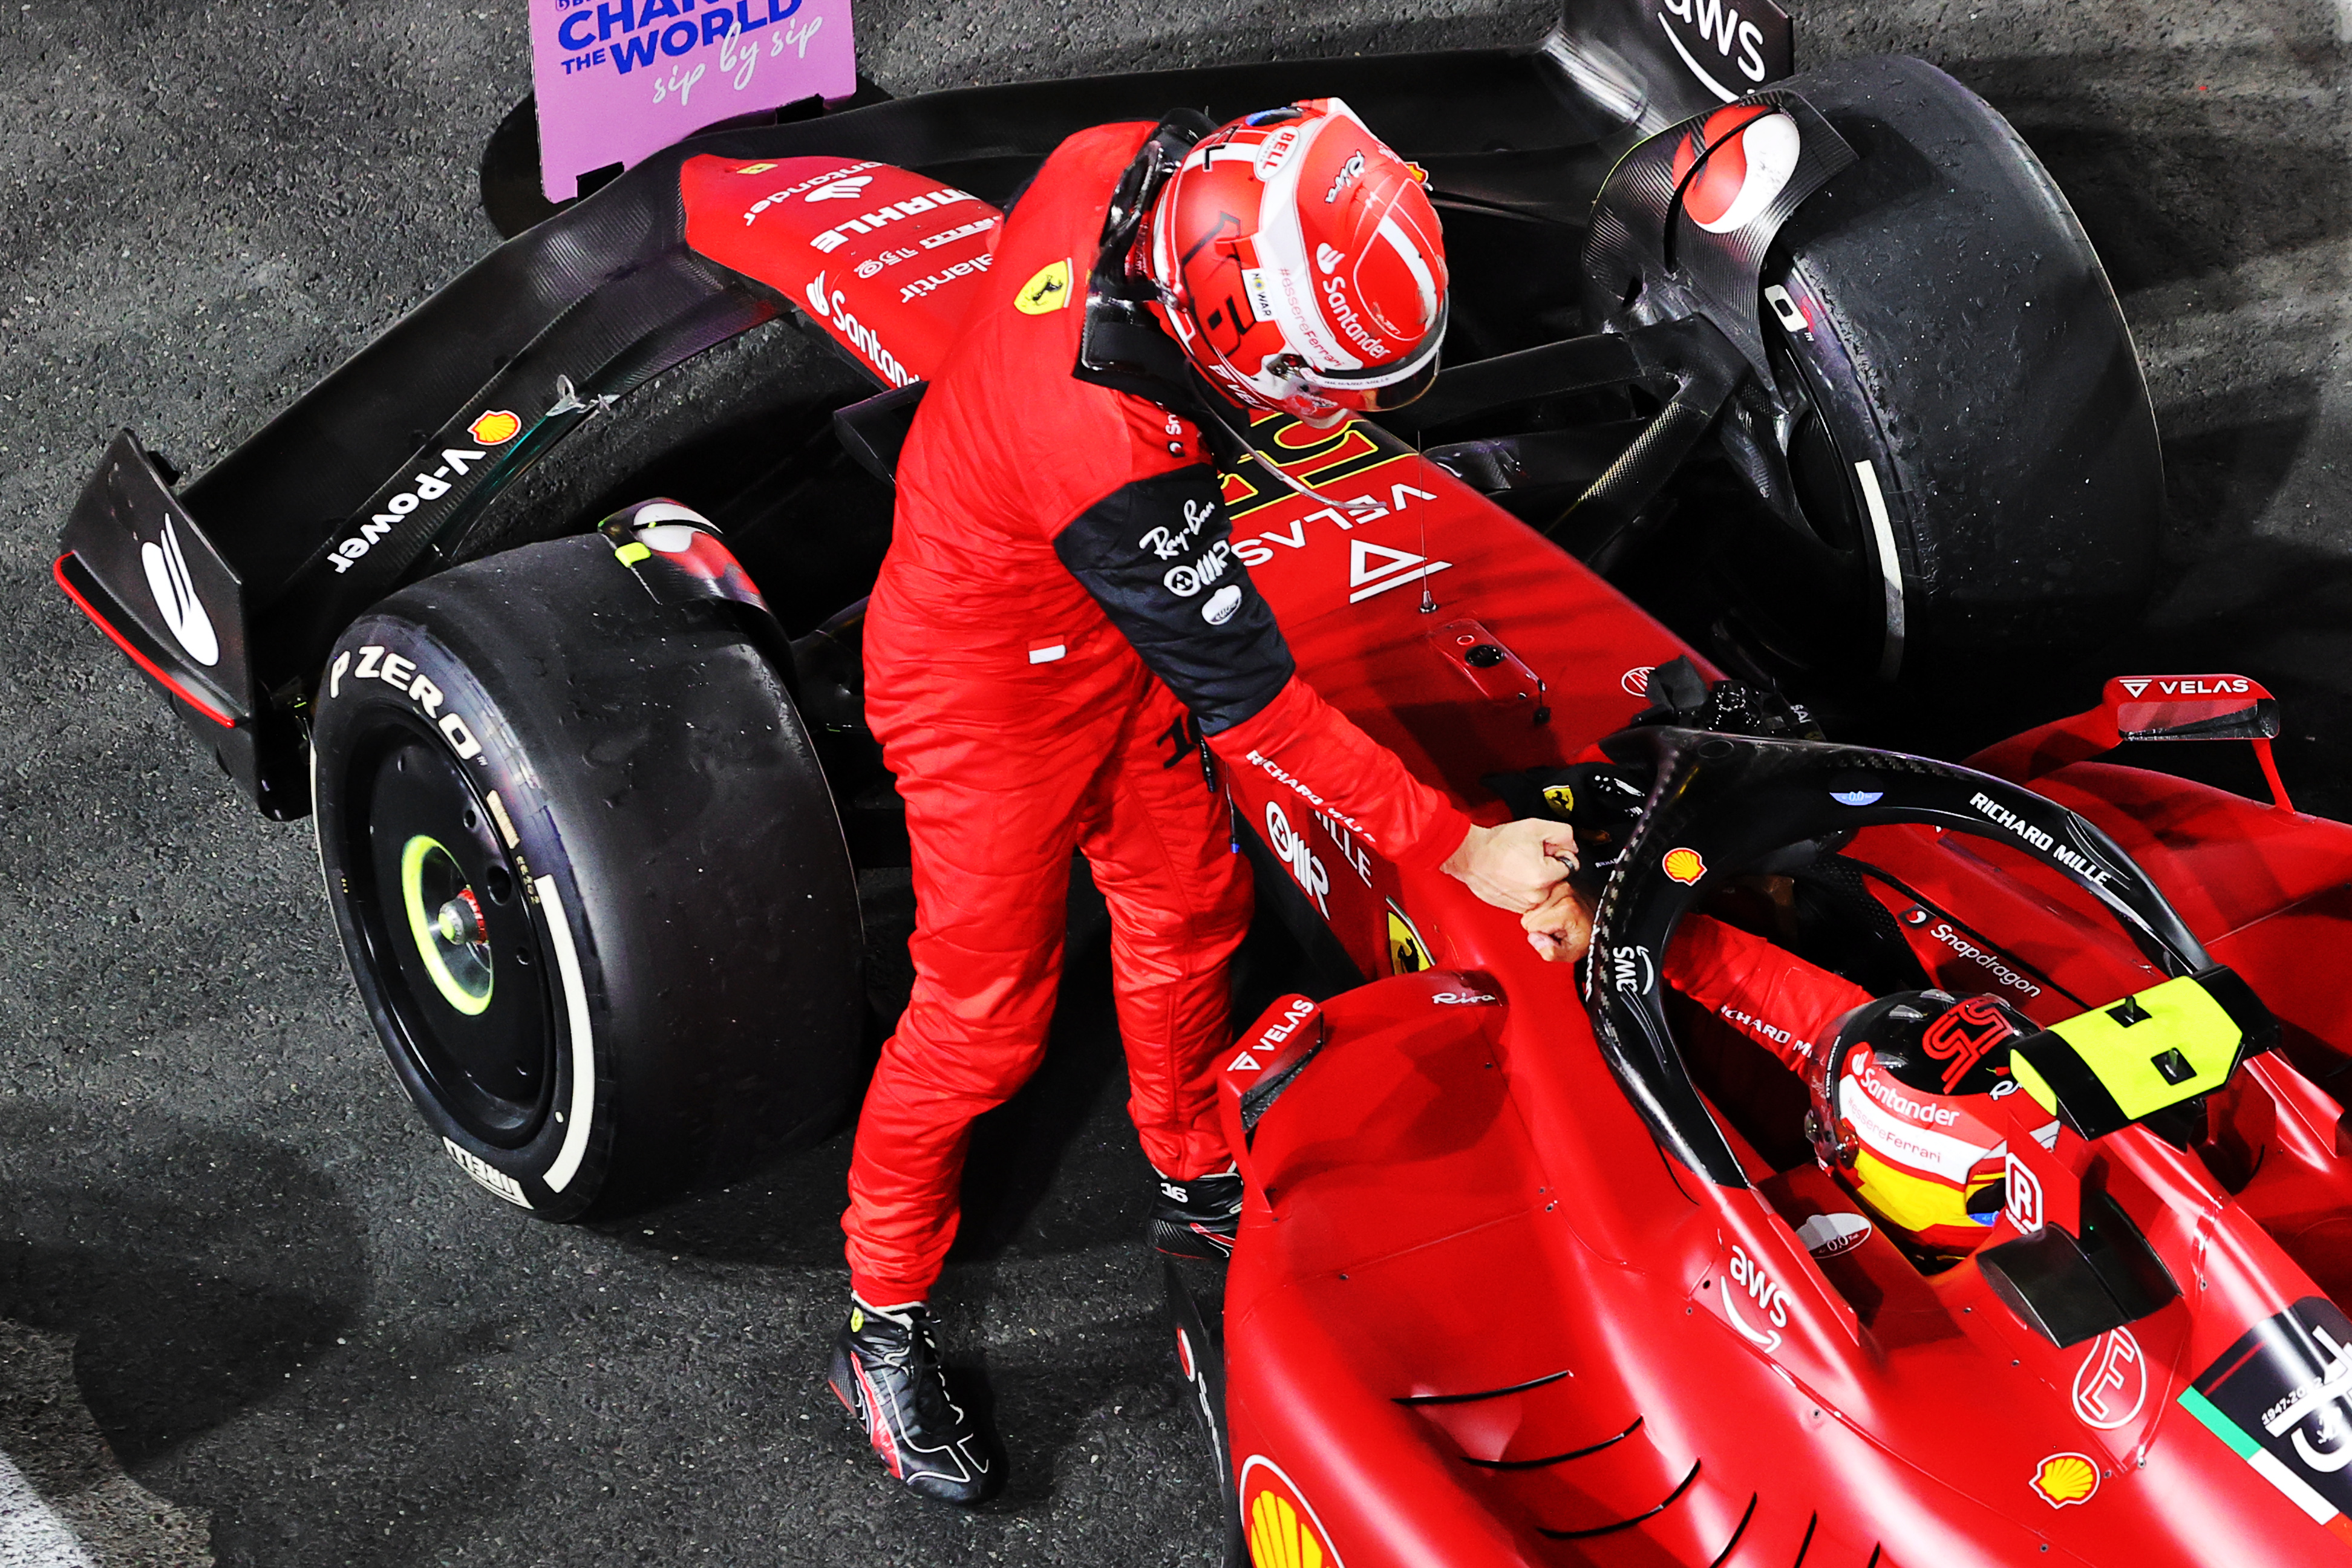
<box><xmin>344</xmin><ymin>724</ymin><xmax>557</xmax><ymax>1147</ymax></box>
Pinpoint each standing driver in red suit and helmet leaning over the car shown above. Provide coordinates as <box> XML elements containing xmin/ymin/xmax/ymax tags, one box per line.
<box><xmin>830</xmin><ymin>99</ymin><xmax>1573</xmax><ymax>1504</ymax></box>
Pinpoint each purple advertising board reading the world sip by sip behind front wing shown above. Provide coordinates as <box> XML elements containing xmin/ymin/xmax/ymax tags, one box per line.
<box><xmin>532</xmin><ymin>0</ymin><xmax>858</xmax><ymax>202</ymax></box>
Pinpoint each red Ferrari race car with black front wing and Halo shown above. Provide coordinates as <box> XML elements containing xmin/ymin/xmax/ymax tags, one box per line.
<box><xmin>41</xmin><ymin>0</ymin><xmax>2352</xmax><ymax>1568</ymax></box>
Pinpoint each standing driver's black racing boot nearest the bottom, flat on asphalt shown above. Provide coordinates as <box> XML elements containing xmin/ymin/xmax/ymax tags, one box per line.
<box><xmin>826</xmin><ymin>1298</ymin><xmax>1004</xmax><ymax>1507</ymax></box>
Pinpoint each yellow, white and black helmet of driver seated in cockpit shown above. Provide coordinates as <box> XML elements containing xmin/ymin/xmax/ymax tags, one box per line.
<box><xmin>1806</xmin><ymin>990</ymin><xmax>2037</xmax><ymax>1255</ymax></box>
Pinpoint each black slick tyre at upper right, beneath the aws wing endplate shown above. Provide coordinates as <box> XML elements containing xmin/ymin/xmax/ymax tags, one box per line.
<box><xmin>1719</xmin><ymin>59</ymin><xmax>2164</xmax><ymax>682</ymax></box>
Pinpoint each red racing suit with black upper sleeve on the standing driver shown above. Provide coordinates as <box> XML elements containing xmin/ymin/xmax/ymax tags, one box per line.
<box><xmin>842</xmin><ymin>125</ymin><xmax>1470</xmax><ymax>1305</ymax></box>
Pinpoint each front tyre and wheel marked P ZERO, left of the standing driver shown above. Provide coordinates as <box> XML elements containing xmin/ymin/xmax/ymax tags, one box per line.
<box><xmin>313</xmin><ymin>536</ymin><xmax>863</xmax><ymax>1220</ymax></box>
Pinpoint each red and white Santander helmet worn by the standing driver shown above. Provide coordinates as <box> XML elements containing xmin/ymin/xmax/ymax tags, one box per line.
<box><xmin>1136</xmin><ymin>99</ymin><xmax>1446</xmax><ymax>425</ymax></box>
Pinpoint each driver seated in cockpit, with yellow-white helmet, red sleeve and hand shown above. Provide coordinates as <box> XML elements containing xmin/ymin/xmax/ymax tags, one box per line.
<box><xmin>1522</xmin><ymin>886</ymin><xmax>2037</xmax><ymax>1258</ymax></box>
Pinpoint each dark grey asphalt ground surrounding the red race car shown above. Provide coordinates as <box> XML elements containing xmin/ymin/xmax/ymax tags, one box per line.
<box><xmin>0</xmin><ymin>0</ymin><xmax>2352</xmax><ymax>1568</ymax></box>
